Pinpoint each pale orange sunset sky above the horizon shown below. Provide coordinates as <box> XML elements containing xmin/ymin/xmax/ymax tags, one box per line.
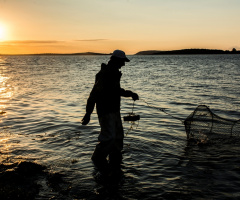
<box><xmin>0</xmin><ymin>0</ymin><xmax>240</xmax><ymax>54</ymax></box>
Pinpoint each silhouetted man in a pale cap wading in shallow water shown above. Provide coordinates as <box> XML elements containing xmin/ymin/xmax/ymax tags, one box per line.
<box><xmin>82</xmin><ymin>50</ymin><xmax>139</xmax><ymax>175</ymax></box>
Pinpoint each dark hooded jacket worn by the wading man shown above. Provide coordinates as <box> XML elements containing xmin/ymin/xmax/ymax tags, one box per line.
<box><xmin>86</xmin><ymin>63</ymin><xmax>133</xmax><ymax>117</ymax></box>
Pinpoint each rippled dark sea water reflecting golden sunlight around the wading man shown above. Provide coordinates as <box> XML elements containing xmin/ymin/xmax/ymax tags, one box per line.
<box><xmin>0</xmin><ymin>55</ymin><xmax>240</xmax><ymax>199</ymax></box>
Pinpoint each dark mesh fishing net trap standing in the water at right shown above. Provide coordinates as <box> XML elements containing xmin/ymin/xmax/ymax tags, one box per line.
<box><xmin>184</xmin><ymin>105</ymin><xmax>240</xmax><ymax>140</ymax></box>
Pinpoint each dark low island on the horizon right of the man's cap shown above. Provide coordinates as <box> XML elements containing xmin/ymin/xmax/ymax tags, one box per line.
<box><xmin>135</xmin><ymin>48</ymin><xmax>240</xmax><ymax>55</ymax></box>
